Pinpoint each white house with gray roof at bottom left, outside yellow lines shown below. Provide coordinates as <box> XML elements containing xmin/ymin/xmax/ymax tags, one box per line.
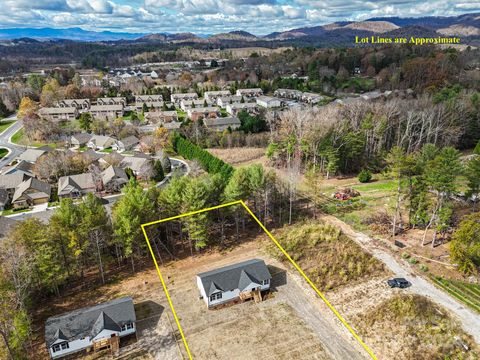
<box><xmin>45</xmin><ymin>296</ymin><xmax>137</xmax><ymax>359</ymax></box>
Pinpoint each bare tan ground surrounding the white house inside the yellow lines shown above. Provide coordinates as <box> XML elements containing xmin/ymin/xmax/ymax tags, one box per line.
<box><xmin>158</xmin><ymin>239</ymin><xmax>368</xmax><ymax>360</ymax></box>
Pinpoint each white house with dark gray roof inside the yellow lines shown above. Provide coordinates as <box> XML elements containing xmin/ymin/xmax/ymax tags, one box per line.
<box><xmin>197</xmin><ymin>259</ymin><xmax>272</xmax><ymax>308</ymax></box>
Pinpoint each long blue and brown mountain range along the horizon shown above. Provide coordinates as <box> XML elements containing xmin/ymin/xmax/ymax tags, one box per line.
<box><xmin>0</xmin><ymin>13</ymin><xmax>480</xmax><ymax>44</ymax></box>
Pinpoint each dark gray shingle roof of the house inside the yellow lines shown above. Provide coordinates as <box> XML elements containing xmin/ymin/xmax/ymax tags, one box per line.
<box><xmin>197</xmin><ymin>259</ymin><xmax>272</xmax><ymax>296</ymax></box>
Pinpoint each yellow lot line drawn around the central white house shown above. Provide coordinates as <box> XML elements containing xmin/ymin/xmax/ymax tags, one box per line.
<box><xmin>142</xmin><ymin>200</ymin><xmax>377</xmax><ymax>360</ymax></box>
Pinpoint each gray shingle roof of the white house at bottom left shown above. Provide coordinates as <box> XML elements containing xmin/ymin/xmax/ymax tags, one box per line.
<box><xmin>45</xmin><ymin>296</ymin><xmax>136</xmax><ymax>347</ymax></box>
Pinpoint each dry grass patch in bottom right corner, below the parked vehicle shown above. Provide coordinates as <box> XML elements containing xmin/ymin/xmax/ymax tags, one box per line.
<box><xmin>354</xmin><ymin>294</ymin><xmax>479</xmax><ymax>360</ymax></box>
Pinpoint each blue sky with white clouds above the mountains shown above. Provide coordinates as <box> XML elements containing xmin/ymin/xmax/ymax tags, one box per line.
<box><xmin>0</xmin><ymin>0</ymin><xmax>480</xmax><ymax>35</ymax></box>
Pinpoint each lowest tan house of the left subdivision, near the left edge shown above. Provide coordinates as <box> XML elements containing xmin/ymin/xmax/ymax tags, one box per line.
<box><xmin>12</xmin><ymin>178</ymin><xmax>52</xmax><ymax>208</ymax></box>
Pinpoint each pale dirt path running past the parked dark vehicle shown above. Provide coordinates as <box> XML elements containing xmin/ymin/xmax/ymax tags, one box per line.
<box><xmin>323</xmin><ymin>215</ymin><xmax>480</xmax><ymax>344</ymax></box>
